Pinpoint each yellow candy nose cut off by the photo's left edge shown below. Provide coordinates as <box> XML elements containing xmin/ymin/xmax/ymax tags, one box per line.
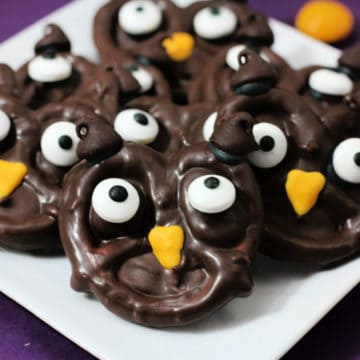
<box><xmin>0</xmin><ymin>160</ymin><xmax>27</xmax><ymax>201</ymax></box>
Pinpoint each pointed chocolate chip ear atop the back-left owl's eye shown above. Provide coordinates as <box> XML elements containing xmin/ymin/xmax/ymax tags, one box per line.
<box><xmin>35</xmin><ymin>24</ymin><xmax>71</xmax><ymax>55</ymax></box>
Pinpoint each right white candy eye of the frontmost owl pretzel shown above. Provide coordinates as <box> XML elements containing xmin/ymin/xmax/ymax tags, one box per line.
<box><xmin>188</xmin><ymin>174</ymin><xmax>236</xmax><ymax>214</ymax></box>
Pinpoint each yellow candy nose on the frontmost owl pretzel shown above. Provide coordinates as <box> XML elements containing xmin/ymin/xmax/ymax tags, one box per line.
<box><xmin>148</xmin><ymin>225</ymin><xmax>184</xmax><ymax>270</ymax></box>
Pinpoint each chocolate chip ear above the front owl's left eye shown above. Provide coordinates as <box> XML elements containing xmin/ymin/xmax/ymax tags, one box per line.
<box><xmin>76</xmin><ymin>115</ymin><xmax>123</xmax><ymax>165</ymax></box>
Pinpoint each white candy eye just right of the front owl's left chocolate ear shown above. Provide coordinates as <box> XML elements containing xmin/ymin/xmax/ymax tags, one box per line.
<box><xmin>114</xmin><ymin>109</ymin><xmax>159</xmax><ymax>144</ymax></box>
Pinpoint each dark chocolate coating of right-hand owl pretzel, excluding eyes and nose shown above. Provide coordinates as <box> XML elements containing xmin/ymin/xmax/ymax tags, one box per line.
<box><xmin>212</xmin><ymin>89</ymin><xmax>360</xmax><ymax>265</ymax></box>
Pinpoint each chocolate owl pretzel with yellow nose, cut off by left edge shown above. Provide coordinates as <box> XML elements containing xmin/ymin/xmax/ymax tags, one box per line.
<box><xmin>0</xmin><ymin>100</ymin><xmax>91</xmax><ymax>252</ymax></box>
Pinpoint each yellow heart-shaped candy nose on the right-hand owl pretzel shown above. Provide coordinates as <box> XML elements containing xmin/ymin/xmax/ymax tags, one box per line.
<box><xmin>285</xmin><ymin>169</ymin><xmax>326</xmax><ymax>216</ymax></box>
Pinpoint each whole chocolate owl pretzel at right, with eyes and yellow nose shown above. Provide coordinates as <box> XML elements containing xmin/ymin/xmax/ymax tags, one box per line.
<box><xmin>212</xmin><ymin>90</ymin><xmax>360</xmax><ymax>264</ymax></box>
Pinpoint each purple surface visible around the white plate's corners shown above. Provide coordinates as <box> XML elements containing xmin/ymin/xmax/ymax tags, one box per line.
<box><xmin>0</xmin><ymin>0</ymin><xmax>360</xmax><ymax>360</ymax></box>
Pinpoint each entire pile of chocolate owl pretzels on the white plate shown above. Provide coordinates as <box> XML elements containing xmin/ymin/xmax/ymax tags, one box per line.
<box><xmin>0</xmin><ymin>0</ymin><xmax>360</xmax><ymax>327</ymax></box>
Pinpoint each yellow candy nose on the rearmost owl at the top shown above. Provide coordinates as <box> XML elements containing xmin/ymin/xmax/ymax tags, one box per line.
<box><xmin>162</xmin><ymin>32</ymin><xmax>195</xmax><ymax>61</ymax></box>
